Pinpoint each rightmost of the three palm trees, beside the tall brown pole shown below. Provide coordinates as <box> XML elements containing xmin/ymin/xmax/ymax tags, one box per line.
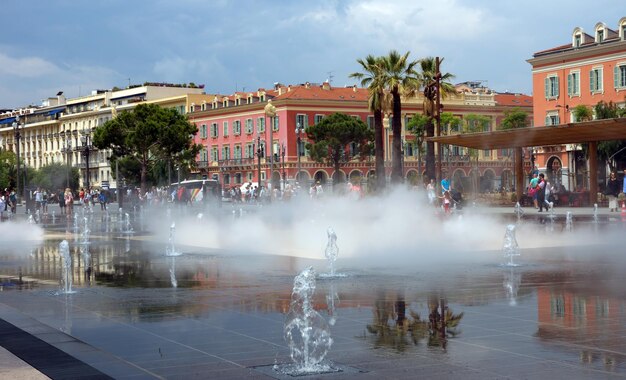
<box><xmin>420</xmin><ymin>57</ymin><xmax>456</xmax><ymax>184</ymax></box>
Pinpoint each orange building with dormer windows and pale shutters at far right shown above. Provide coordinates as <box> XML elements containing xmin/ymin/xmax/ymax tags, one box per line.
<box><xmin>528</xmin><ymin>17</ymin><xmax>626</xmax><ymax>189</ymax></box>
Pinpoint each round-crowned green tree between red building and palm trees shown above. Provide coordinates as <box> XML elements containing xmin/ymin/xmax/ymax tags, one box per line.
<box><xmin>305</xmin><ymin>113</ymin><xmax>374</xmax><ymax>185</ymax></box>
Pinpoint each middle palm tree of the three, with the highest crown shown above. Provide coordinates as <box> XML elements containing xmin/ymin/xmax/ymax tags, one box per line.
<box><xmin>381</xmin><ymin>50</ymin><xmax>421</xmax><ymax>183</ymax></box>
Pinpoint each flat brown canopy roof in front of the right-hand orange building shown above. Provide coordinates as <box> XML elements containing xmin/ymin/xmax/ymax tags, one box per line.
<box><xmin>426</xmin><ymin>118</ymin><xmax>626</xmax><ymax>149</ymax></box>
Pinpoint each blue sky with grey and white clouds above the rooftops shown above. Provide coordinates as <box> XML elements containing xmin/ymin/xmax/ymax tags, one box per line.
<box><xmin>0</xmin><ymin>0</ymin><xmax>626</xmax><ymax>109</ymax></box>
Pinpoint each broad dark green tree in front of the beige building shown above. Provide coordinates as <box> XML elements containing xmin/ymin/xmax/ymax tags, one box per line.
<box><xmin>93</xmin><ymin>104</ymin><xmax>201</xmax><ymax>192</ymax></box>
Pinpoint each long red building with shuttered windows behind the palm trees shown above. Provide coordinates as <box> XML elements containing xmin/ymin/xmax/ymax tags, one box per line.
<box><xmin>189</xmin><ymin>82</ymin><xmax>532</xmax><ymax>190</ymax></box>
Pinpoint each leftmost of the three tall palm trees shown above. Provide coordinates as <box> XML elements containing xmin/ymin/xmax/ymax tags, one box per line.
<box><xmin>350</xmin><ymin>54</ymin><xmax>386</xmax><ymax>191</ymax></box>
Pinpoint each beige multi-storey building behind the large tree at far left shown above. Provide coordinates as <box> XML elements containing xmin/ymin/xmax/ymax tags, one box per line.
<box><xmin>0</xmin><ymin>84</ymin><xmax>208</xmax><ymax>188</ymax></box>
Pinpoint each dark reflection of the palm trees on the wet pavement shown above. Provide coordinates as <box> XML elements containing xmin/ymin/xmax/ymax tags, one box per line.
<box><xmin>367</xmin><ymin>296</ymin><xmax>463</xmax><ymax>352</ymax></box>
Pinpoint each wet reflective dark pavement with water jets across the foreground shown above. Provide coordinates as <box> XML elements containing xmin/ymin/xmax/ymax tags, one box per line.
<box><xmin>0</xmin><ymin>202</ymin><xmax>626</xmax><ymax>379</ymax></box>
